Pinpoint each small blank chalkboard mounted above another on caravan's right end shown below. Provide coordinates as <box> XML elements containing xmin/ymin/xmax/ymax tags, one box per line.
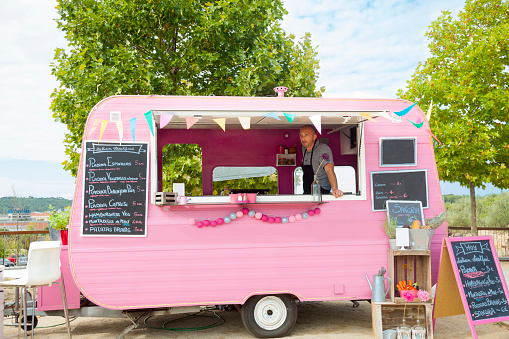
<box><xmin>380</xmin><ymin>138</ymin><xmax>417</xmax><ymax>167</ymax></box>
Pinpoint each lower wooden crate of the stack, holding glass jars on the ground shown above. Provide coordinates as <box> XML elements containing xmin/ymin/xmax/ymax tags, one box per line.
<box><xmin>371</xmin><ymin>302</ymin><xmax>433</xmax><ymax>339</ymax></box>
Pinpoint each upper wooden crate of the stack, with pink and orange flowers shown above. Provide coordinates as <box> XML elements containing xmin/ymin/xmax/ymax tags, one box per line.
<box><xmin>389</xmin><ymin>249</ymin><xmax>432</xmax><ymax>303</ymax></box>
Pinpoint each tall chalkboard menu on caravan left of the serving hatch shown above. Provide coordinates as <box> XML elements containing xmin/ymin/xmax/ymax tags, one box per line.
<box><xmin>82</xmin><ymin>142</ymin><xmax>148</xmax><ymax>236</ymax></box>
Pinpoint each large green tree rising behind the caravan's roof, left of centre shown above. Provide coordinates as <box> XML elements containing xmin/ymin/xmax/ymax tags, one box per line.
<box><xmin>51</xmin><ymin>0</ymin><xmax>324</xmax><ymax>175</ymax></box>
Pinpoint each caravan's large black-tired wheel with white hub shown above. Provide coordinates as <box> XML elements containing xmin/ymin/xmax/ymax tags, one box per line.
<box><xmin>240</xmin><ymin>294</ymin><xmax>297</xmax><ymax>338</ymax></box>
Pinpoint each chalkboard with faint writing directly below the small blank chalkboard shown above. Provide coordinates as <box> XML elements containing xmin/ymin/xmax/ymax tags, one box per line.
<box><xmin>371</xmin><ymin>169</ymin><xmax>428</xmax><ymax>211</ymax></box>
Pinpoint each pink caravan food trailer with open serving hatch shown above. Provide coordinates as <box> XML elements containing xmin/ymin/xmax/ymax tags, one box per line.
<box><xmin>60</xmin><ymin>96</ymin><xmax>446</xmax><ymax>337</ymax></box>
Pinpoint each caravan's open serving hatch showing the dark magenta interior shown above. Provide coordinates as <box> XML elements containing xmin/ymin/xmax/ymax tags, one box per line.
<box><xmin>151</xmin><ymin>111</ymin><xmax>376</xmax><ymax>201</ymax></box>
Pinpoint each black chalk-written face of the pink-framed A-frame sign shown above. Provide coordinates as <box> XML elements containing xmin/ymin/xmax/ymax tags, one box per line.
<box><xmin>451</xmin><ymin>240</ymin><xmax>509</xmax><ymax>321</ymax></box>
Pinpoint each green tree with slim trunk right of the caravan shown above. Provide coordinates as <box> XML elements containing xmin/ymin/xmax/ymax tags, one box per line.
<box><xmin>398</xmin><ymin>0</ymin><xmax>509</xmax><ymax>233</ymax></box>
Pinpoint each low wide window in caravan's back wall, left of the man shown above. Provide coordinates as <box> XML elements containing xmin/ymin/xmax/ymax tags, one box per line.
<box><xmin>212</xmin><ymin>166</ymin><xmax>278</xmax><ymax>195</ymax></box>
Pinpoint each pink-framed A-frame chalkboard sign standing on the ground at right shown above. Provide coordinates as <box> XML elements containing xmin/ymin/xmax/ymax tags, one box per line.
<box><xmin>433</xmin><ymin>236</ymin><xmax>509</xmax><ymax>338</ymax></box>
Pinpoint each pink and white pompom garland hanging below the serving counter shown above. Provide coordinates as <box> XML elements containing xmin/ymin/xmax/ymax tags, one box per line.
<box><xmin>187</xmin><ymin>207</ymin><xmax>322</xmax><ymax>228</ymax></box>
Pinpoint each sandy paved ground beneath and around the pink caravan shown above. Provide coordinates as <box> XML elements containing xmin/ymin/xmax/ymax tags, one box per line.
<box><xmin>4</xmin><ymin>262</ymin><xmax>509</xmax><ymax>339</ymax></box>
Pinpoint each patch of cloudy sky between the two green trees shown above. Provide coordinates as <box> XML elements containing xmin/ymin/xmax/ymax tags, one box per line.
<box><xmin>283</xmin><ymin>0</ymin><xmax>464</xmax><ymax>98</ymax></box>
